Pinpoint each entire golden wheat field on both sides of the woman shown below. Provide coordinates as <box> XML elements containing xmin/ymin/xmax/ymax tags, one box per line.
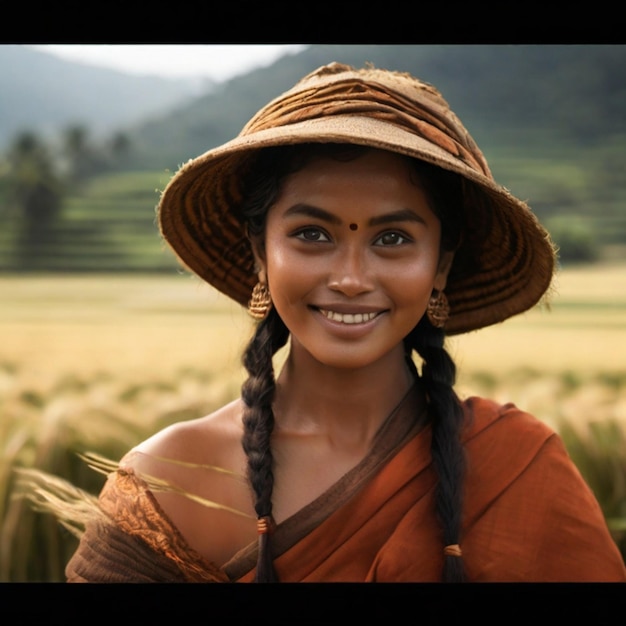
<box><xmin>0</xmin><ymin>264</ymin><xmax>626</xmax><ymax>581</ymax></box>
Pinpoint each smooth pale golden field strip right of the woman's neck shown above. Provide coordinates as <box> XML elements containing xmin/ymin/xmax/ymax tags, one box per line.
<box><xmin>451</xmin><ymin>264</ymin><xmax>626</xmax><ymax>374</ymax></box>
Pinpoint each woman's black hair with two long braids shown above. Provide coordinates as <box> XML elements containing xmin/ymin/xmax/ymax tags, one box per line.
<box><xmin>238</xmin><ymin>143</ymin><xmax>464</xmax><ymax>582</ymax></box>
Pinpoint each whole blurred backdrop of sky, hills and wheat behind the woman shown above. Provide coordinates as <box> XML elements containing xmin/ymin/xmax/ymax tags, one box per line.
<box><xmin>0</xmin><ymin>44</ymin><xmax>626</xmax><ymax>581</ymax></box>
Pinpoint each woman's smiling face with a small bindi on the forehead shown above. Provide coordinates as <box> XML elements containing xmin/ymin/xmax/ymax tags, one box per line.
<box><xmin>257</xmin><ymin>150</ymin><xmax>452</xmax><ymax>368</ymax></box>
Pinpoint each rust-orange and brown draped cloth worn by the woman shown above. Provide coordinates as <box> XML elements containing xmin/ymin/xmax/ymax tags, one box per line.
<box><xmin>66</xmin><ymin>397</ymin><xmax>626</xmax><ymax>582</ymax></box>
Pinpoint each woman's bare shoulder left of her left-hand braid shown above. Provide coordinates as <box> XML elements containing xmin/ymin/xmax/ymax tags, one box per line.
<box><xmin>120</xmin><ymin>400</ymin><xmax>256</xmax><ymax>565</ymax></box>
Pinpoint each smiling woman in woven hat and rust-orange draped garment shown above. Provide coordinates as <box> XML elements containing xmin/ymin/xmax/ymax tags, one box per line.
<box><xmin>61</xmin><ymin>64</ymin><xmax>626</xmax><ymax>582</ymax></box>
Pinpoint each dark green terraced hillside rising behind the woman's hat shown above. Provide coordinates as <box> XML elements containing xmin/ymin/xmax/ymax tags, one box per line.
<box><xmin>0</xmin><ymin>45</ymin><xmax>626</xmax><ymax>271</ymax></box>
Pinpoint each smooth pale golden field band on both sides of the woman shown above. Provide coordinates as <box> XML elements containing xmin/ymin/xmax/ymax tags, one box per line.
<box><xmin>0</xmin><ymin>264</ymin><xmax>626</xmax><ymax>375</ymax></box>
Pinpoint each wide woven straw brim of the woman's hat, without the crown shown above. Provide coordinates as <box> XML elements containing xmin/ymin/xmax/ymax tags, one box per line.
<box><xmin>158</xmin><ymin>115</ymin><xmax>555</xmax><ymax>335</ymax></box>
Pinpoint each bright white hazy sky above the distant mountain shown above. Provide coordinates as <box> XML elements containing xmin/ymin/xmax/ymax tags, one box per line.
<box><xmin>29</xmin><ymin>44</ymin><xmax>304</xmax><ymax>81</ymax></box>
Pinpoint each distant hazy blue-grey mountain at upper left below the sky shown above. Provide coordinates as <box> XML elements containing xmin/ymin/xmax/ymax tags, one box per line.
<box><xmin>0</xmin><ymin>44</ymin><xmax>210</xmax><ymax>150</ymax></box>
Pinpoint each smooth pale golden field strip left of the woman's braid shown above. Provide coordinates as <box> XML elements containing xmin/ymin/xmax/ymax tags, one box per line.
<box><xmin>0</xmin><ymin>275</ymin><xmax>250</xmax><ymax>380</ymax></box>
